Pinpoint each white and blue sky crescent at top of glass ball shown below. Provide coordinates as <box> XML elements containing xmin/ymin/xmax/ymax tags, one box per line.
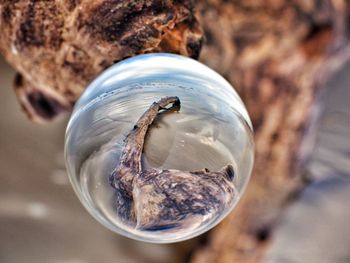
<box><xmin>75</xmin><ymin>53</ymin><xmax>252</xmax><ymax>131</ymax></box>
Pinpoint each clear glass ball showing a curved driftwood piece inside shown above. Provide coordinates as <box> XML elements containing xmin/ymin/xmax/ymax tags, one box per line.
<box><xmin>65</xmin><ymin>54</ymin><xmax>254</xmax><ymax>243</ymax></box>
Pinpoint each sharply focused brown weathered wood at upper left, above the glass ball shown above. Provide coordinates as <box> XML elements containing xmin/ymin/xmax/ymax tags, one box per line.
<box><xmin>0</xmin><ymin>0</ymin><xmax>202</xmax><ymax>122</ymax></box>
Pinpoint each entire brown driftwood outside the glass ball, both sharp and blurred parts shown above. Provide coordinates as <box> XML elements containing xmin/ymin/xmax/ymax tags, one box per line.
<box><xmin>0</xmin><ymin>0</ymin><xmax>350</xmax><ymax>263</ymax></box>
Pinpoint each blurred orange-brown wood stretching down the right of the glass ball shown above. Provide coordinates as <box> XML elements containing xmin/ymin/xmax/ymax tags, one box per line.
<box><xmin>192</xmin><ymin>0</ymin><xmax>350</xmax><ymax>263</ymax></box>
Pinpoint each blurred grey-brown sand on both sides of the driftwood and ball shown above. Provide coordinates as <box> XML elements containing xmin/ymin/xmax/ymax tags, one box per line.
<box><xmin>0</xmin><ymin>54</ymin><xmax>350</xmax><ymax>263</ymax></box>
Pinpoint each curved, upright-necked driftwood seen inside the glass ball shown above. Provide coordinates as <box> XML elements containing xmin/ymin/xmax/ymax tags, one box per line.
<box><xmin>110</xmin><ymin>97</ymin><xmax>238</xmax><ymax>235</ymax></box>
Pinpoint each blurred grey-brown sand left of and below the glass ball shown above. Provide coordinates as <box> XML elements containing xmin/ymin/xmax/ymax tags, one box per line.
<box><xmin>0</xmin><ymin>57</ymin><xmax>188</xmax><ymax>263</ymax></box>
